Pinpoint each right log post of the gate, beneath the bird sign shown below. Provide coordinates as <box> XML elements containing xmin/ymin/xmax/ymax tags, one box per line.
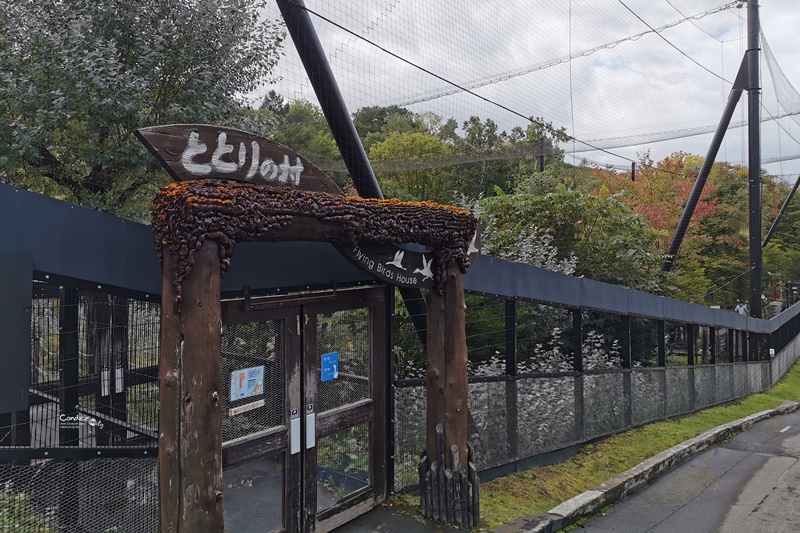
<box><xmin>427</xmin><ymin>265</ymin><xmax>467</xmax><ymax>468</ymax></box>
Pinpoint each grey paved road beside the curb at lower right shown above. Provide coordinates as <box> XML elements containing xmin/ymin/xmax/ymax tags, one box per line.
<box><xmin>577</xmin><ymin>412</ymin><xmax>800</xmax><ymax>533</ymax></box>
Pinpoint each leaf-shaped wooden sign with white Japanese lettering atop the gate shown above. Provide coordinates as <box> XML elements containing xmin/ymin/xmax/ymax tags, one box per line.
<box><xmin>134</xmin><ymin>124</ymin><xmax>342</xmax><ymax>194</ymax></box>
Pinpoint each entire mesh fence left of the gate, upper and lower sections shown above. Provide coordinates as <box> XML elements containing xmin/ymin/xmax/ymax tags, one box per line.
<box><xmin>0</xmin><ymin>282</ymin><xmax>160</xmax><ymax>533</ymax></box>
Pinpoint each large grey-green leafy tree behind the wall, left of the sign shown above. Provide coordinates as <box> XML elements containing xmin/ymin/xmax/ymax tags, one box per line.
<box><xmin>0</xmin><ymin>0</ymin><xmax>283</xmax><ymax>215</ymax></box>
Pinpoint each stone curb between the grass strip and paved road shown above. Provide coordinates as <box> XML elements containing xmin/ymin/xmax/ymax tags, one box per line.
<box><xmin>491</xmin><ymin>402</ymin><xmax>800</xmax><ymax>533</ymax></box>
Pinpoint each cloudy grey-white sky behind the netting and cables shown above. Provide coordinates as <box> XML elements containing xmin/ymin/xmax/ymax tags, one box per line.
<box><xmin>264</xmin><ymin>0</ymin><xmax>800</xmax><ymax>180</ymax></box>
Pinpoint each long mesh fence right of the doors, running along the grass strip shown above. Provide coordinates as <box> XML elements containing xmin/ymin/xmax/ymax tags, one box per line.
<box><xmin>393</xmin><ymin>295</ymin><xmax>800</xmax><ymax>490</ymax></box>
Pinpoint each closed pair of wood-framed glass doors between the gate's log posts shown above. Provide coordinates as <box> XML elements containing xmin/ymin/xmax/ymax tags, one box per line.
<box><xmin>221</xmin><ymin>287</ymin><xmax>387</xmax><ymax>532</ymax></box>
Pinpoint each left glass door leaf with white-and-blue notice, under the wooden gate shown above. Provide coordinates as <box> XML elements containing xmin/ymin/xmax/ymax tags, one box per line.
<box><xmin>221</xmin><ymin>301</ymin><xmax>302</xmax><ymax>533</ymax></box>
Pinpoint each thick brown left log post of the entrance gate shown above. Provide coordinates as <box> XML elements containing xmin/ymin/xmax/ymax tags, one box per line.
<box><xmin>158</xmin><ymin>240</ymin><xmax>224</xmax><ymax>533</ymax></box>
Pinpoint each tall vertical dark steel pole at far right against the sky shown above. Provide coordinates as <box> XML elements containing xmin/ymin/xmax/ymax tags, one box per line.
<box><xmin>747</xmin><ymin>0</ymin><xmax>762</xmax><ymax>318</ymax></box>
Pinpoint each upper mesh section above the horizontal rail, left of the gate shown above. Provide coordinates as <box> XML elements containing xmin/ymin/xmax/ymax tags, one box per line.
<box><xmin>24</xmin><ymin>283</ymin><xmax>160</xmax><ymax>447</ymax></box>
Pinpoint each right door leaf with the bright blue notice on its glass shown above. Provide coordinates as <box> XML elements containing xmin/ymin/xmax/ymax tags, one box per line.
<box><xmin>303</xmin><ymin>288</ymin><xmax>387</xmax><ymax>532</ymax></box>
